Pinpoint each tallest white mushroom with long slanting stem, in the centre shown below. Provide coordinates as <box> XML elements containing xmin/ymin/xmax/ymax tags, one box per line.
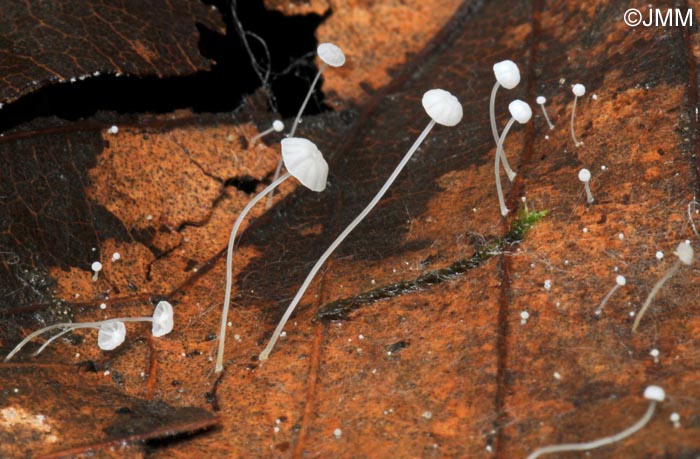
<box><xmin>258</xmin><ymin>89</ymin><xmax>462</xmax><ymax>361</ymax></box>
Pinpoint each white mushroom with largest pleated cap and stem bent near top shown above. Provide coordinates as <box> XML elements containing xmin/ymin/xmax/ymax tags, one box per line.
<box><xmin>214</xmin><ymin>137</ymin><xmax>328</xmax><ymax>373</ymax></box>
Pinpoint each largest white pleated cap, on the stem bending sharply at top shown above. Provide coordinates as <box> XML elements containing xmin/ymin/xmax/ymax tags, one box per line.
<box><xmin>282</xmin><ymin>137</ymin><xmax>328</xmax><ymax>191</ymax></box>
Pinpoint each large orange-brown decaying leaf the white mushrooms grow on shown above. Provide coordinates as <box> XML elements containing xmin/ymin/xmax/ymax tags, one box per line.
<box><xmin>0</xmin><ymin>0</ymin><xmax>700</xmax><ymax>458</ymax></box>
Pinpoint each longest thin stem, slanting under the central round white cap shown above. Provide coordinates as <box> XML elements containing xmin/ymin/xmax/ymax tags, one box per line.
<box><xmin>258</xmin><ymin>120</ymin><xmax>435</xmax><ymax>361</ymax></box>
